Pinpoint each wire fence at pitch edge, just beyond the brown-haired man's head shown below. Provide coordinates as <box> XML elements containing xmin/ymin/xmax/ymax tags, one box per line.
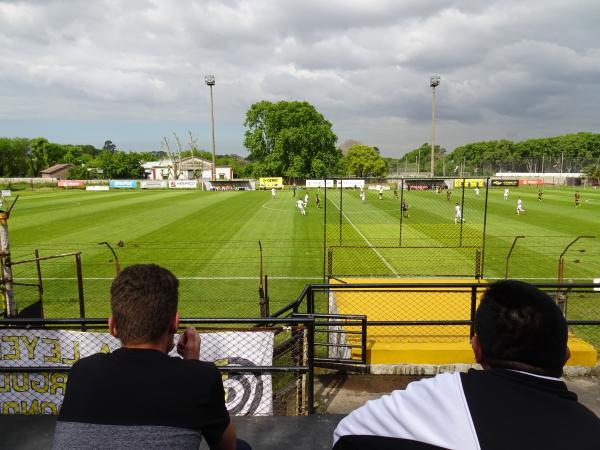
<box><xmin>4</xmin><ymin>239</ymin><xmax>323</xmax><ymax>318</ymax></box>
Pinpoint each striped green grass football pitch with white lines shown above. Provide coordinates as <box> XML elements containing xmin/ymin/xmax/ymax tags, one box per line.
<box><xmin>4</xmin><ymin>188</ymin><xmax>600</xmax><ymax>319</ymax></box>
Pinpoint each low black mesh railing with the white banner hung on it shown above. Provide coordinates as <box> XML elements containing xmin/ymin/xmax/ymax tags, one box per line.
<box><xmin>0</xmin><ymin>318</ymin><xmax>314</xmax><ymax>416</ymax></box>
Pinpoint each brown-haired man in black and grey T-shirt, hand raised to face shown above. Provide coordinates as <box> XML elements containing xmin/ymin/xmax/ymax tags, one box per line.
<box><xmin>54</xmin><ymin>264</ymin><xmax>249</xmax><ymax>450</ymax></box>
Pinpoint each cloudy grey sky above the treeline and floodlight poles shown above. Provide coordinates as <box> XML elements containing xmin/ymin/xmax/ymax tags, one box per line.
<box><xmin>0</xmin><ymin>0</ymin><xmax>600</xmax><ymax>156</ymax></box>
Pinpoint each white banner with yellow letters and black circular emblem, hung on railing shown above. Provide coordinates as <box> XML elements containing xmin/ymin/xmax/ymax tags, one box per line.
<box><xmin>0</xmin><ymin>329</ymin><xmax>273</xmax><ymax>415</ymax></box>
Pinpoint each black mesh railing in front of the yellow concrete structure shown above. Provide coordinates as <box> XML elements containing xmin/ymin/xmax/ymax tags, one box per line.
<box><xmin>273</xmin><ymin>279</ymin><xmax>600</xmax><ymax>372</ymax></box>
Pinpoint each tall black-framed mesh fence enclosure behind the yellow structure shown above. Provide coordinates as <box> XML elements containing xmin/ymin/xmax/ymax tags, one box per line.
<box><xmin>324</xmin><ymin>178</ymin><xmax>488</xmax><ymax>278</ymax></box>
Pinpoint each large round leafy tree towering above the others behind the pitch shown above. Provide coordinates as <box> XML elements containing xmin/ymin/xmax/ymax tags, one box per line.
<box><xmin>244</xmin><ymin>100</ymin><xmax>342</xmax><ymax>178</ymax></box>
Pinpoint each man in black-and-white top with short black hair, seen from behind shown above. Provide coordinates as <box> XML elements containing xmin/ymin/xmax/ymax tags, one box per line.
<box><xmin>334</xmin><ymin>281</ymin><xmax>600</xmax><ymax>450</ymax></box>
